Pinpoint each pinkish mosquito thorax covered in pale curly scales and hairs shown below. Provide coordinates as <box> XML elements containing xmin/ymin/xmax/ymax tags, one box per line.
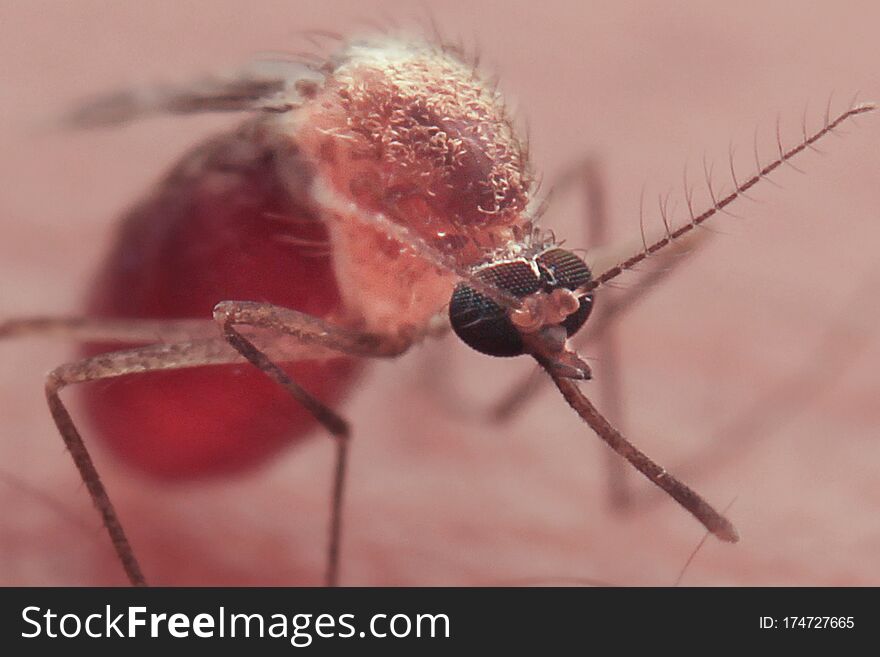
<box><xmin>278</xmin><ymin>39</ymin><xmax>532</xmax><ymax>332</ymax></box>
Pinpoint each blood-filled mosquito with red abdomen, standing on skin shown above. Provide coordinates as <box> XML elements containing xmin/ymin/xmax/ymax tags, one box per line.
<box><xmin>0</xmin><ymin>35</ymin><xmax>874</xmax><ymax>586</ymax></box>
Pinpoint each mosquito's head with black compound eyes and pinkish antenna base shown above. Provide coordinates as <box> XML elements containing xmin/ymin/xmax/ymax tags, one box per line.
<box><xmin>449</xmin><ymin>245</ymin><xmax>593</xmax><ymax>379</ymax></box>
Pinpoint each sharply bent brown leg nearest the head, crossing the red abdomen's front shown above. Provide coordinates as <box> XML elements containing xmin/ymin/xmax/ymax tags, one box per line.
<box><xmin>214</xmin><ymin>301</ymin><xmax>411</xmax><ymax>586</ymax></box>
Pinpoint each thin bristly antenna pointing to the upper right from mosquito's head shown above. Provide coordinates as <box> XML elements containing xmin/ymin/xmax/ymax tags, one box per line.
<box><xmin>579</xmin><ymin>103</ymin><xmax>877</xmax><ymax>293</ymax></box>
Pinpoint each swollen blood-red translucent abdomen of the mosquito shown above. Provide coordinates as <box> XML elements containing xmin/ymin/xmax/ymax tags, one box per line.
<box><xmin>83</xmin><ymin>129</ymin><xmax>357</xmax><ymax>478</ymax></box>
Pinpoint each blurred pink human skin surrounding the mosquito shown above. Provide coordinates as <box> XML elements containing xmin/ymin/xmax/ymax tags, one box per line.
<box><xmin>0</xmin><ymin>0</ymin><xmax>880</xmax><ymax>585</ymax></box>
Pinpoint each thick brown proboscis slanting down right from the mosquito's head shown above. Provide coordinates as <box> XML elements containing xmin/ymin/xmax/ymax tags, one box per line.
<box><xmin>535</xmin><ymin>362</ymin><xmax>739</xmax><ymax>543</ymax></box>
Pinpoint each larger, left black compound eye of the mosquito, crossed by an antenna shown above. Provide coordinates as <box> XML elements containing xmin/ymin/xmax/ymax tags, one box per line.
<box><xmin>449</xmin><ymin>260</ymin><xmax>540</xmax><ymax>357</ymax></box>
